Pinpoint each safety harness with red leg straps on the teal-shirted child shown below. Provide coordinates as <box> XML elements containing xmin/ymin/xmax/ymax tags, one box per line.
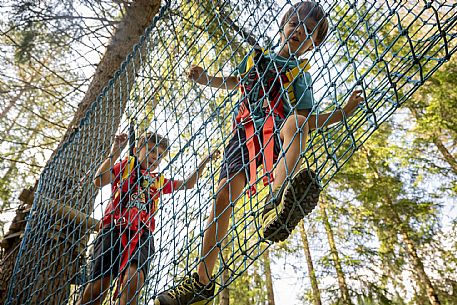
<box><xmin>234</xmin><ymin>49</ymin><xmax>309</xmax><ymax>196</ymax></box>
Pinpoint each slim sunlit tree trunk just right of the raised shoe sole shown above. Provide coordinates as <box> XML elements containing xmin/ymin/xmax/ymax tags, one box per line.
<box><xmin>319</xmin><ymin>203</ymin><xmax>352</xmax><ymax>305</ymax></box>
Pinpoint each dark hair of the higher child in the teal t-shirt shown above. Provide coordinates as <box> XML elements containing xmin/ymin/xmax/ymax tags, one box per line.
<box><xmin>280</xmin><ymin>1</ymin><xmax>328</xmax><ymax>46</ymax></box>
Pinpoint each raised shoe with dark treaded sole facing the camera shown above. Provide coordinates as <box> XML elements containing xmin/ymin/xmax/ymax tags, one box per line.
<box><xmin>263</xmin><ymin>169</ymin><xmax>321</xmax><ymax>242</ymax></box>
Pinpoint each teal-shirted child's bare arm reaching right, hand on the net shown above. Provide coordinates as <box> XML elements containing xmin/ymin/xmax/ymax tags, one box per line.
<box><xmin>297</xmin><ymin>90</ymin><xmax>364</xmax><ymax>130</ymax></box>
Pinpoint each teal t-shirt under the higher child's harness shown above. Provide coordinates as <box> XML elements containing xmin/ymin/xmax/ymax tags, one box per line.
<box><xmin>236</xmin><ymin>52</ymin><xmax>314</xmax><ymax>127</ymax></box>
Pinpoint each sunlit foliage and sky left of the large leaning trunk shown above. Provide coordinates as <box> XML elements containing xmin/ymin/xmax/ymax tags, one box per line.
<box><xmin>0</xmin><ymin>0</ymin><xmax>123</xmax><ymax>216</ymax></box>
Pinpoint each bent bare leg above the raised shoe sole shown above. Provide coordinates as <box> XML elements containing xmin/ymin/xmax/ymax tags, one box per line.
<box><xmin>273</xmin><ymin>115</ymin><xmax>309</xmax><ymax>190</ymax></box>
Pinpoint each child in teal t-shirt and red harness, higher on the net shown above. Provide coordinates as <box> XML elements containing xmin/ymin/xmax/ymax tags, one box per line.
<box><xmin>155</xmin><ymin>1</ymin><xmax>363</xmax><ymax>305</ymax></box>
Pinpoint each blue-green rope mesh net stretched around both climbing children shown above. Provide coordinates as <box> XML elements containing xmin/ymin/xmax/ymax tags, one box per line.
<box><xmin>7</xmin><ymin>0</ymin><xmax>456</xmax><ymax>304</ymax></box>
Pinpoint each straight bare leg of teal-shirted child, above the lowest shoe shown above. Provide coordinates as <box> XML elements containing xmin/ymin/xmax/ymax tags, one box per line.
<box><xmin>197</xmin><ymin>172</ymin><xmax>246</xmax><ymax>284</ymax></box>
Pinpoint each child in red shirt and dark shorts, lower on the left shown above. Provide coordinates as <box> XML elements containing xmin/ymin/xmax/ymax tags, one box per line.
<box><xmin>78</xmin><ymin>133</ymin><xmax>218</xmax><ymax>305</ymax></box>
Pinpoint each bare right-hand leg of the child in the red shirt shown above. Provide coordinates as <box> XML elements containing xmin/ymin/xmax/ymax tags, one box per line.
<box><xmin>120</xmin><ymin>262</ymin><xmax>144</xmax><ymax>305</ymax></box>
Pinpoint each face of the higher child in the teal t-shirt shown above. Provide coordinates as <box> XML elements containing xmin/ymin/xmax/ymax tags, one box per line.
<box><xmin>279</xmin><ymin>15</ymin><xmax>317</xmax><ymax>57</ymax></box>
